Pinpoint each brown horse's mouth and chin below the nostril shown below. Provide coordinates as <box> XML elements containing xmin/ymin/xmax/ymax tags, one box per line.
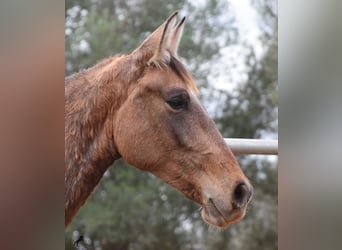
<box><xmin>200</xmin><ymin>198</ymin><xmax>246</xmax><ymax>229</ymax></box>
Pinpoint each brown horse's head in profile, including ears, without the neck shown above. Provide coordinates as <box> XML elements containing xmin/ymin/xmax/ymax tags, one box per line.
<box><xmin>113</xmin><ymin>12</ymin><xmax>253</xmax><ymax>228</ymax></box>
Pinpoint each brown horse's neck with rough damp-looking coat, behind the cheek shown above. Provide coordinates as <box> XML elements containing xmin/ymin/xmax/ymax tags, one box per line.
<box><xmin>65</xmin><ymin>56</ymin><xmax>141</xmax><ymax>225</ymax></box>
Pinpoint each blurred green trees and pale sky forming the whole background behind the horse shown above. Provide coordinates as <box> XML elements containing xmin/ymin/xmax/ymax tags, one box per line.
<box><xmin>65</xmin><ymin>0</ymin><xmax>278</xmax><ymax>250</ymax></box>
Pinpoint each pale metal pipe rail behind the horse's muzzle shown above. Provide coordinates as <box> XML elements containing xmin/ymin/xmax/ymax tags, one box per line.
<box><xmin>224</xmin><ymin>138</ymin><xmax>278</xmax><ymax>155</ymax></box>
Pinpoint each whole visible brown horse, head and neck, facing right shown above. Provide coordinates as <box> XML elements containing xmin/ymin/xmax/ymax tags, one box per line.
<box><xmin>65</xmin><ymin>12</ymin><xmax>253</xmax><ymax>229</ymax></box>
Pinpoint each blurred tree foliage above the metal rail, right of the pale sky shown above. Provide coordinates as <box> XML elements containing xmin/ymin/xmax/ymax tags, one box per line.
<box><xmin>217</xmin><ymin>0</ymin><xmax>278</xmax><ymax>138</ymax></box>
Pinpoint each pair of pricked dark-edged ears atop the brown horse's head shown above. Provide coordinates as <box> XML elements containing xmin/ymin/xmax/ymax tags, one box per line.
<box><xmin>136</xmin><ymin>11</ymin><xmax>185</xmax><ymax>65</ymax></box>
